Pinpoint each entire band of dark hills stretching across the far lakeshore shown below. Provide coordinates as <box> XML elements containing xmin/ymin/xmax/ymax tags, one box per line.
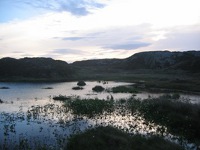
<box><xmin>0</xmin><ymin>51</ymin><xmax>200</xmax><ymax>81</ymax></box>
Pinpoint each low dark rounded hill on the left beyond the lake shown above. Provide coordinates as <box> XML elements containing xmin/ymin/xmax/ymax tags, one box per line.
<box><xmin>0</xmin><ymin>58</ymin><xmax>73</xmax><ymax>81</ymax></box>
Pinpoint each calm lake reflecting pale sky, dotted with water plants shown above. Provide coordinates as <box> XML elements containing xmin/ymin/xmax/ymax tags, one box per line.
<box><xmin>0</xmin><ymin>81</ymin><xmax>200</xmax><ymax>149</ymax></box>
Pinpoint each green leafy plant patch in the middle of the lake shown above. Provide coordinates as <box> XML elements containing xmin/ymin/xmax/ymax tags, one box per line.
<box><xmin>65</xmin><ymin>99</ymin><xmax>114</xmax><ymax>117</ymax></box>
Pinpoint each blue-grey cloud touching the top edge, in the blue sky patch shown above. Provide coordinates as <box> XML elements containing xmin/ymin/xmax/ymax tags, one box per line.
<box><xmin>22</xmin><ymin>0</ymin><xmax>105</xmax><ymax>16</ymax></box>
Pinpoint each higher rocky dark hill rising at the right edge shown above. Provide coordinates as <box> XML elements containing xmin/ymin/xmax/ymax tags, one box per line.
<box><xmin>124</xmin><ymin>51</ymin><xmax>200</xmax><ymax>72</ymax></box>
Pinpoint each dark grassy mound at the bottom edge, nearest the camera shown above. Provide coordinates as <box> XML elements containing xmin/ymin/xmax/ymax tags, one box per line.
<box><xmin>66</xmin><ymin>126</ymin><xmax>183</xmax><ymax>150</ymax></box>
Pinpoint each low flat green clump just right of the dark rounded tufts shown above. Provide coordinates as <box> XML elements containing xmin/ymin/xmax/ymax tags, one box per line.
<box><xmin>111</xmin><ymin>86</ymin><xmax>138</xmax><ymax>93</ymax></box>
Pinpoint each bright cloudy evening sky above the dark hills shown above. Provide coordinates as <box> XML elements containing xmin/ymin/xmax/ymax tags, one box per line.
<box><xmin>0</xmin><ymin>0</ymin><xmax>200</xmax><ymax>63</ymax></box>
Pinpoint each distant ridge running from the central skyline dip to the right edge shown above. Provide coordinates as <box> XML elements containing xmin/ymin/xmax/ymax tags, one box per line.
<box><xmin>72</xmin><ymin>51</ymin><xmax>200</xmax><ymax>72</ymax></box>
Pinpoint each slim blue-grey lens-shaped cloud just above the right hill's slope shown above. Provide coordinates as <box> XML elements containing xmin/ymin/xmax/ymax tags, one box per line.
<box><xmin>103</xmin><ymin>42</ymin><xmax>151</xmax><ymax>50</ymax></box>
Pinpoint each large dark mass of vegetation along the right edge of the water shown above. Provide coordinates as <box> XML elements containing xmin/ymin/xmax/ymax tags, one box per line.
<box><xmin>129</xmin><ymin>95</ymin><xmax>200</xmax><ymax>143</ymax></box>
